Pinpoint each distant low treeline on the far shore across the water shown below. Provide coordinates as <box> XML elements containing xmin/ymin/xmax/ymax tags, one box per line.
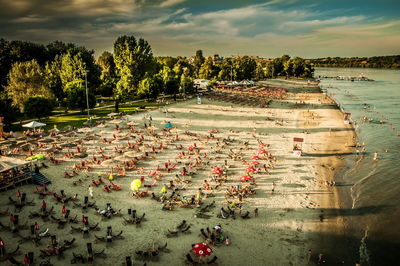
<box><xmin>307</xmin><ymin>55</ymin><xmax>400</xmax><ymax>69</ymax></box>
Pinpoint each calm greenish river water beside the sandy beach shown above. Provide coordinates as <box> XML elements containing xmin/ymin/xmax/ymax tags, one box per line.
<box><xmin>314</xmin><ymin>68</ymin><xmax>400</xmax><ymax>265</ymax></box>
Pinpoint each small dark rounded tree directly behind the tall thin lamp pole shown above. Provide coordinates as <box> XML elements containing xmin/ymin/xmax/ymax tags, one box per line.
<box><xmin>66</xmin><ymin>82</ymin><xmax>96</xmax><ymax>112</ymax></box>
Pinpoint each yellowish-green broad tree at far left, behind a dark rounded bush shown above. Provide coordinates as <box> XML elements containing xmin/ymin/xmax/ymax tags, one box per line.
<box><xmin>5</xmin><ymin>60</ymin><xmax>53</xmax><ymax>112</ymax></box>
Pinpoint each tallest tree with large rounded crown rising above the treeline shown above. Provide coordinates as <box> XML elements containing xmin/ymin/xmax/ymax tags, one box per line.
<box><xmin>114</xmin><ymin>35</ymin><xmax>154</xmax><ymax>111</ymax></box>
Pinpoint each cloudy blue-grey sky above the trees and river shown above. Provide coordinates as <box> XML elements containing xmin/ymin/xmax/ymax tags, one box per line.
<box><xmin>0</xmin><ymin>0</ymin><xmax>400</xmax><ymax>58</ymax></box>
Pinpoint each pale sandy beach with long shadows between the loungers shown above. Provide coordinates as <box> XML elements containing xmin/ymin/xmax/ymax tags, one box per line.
<box><xmin>0</xmin><ymin>80</ymin><xmax>354</xmax><ymax>265</ymax></box>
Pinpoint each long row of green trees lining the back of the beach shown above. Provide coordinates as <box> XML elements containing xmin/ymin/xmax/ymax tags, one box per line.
<box><xmin>0</xmin><ymin>35</ymin><xmax>314</xmax><ymax>122</ymax></box>
